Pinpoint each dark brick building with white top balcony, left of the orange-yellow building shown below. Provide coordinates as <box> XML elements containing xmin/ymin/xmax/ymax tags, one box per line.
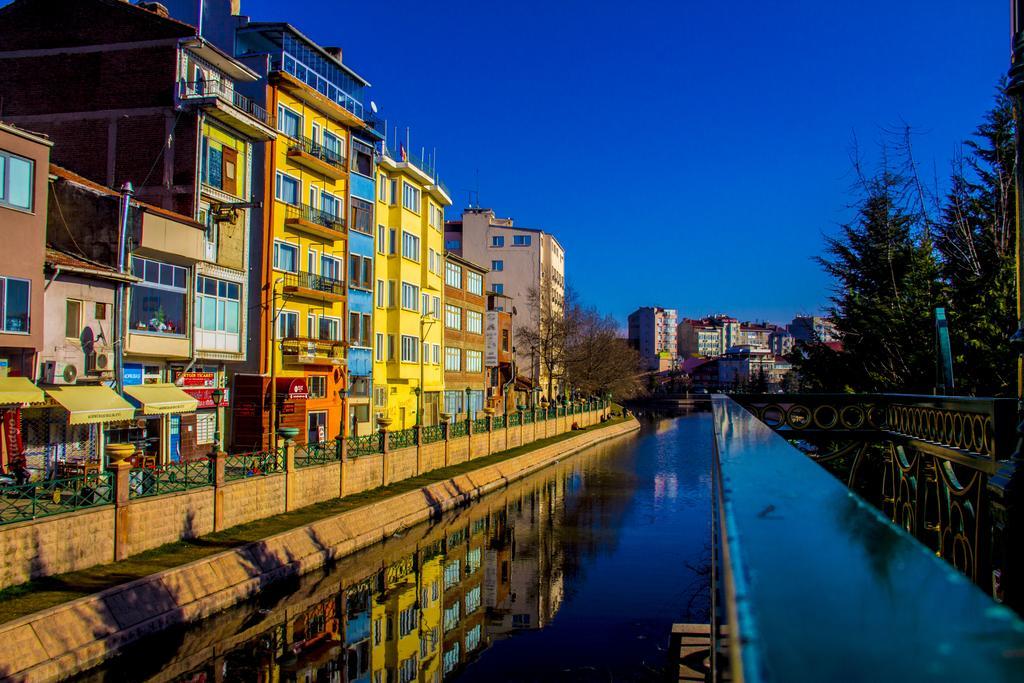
<box><xmin>0</xmin><ymin>0</ymin><xmax>276</xmax><ymax>454</ymax></box>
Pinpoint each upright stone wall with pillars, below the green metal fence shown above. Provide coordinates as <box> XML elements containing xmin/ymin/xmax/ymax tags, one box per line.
<box><xmin>0</xmin><ymin>408</ymin><xmax>608</xmax><ymax>589</ymax></box>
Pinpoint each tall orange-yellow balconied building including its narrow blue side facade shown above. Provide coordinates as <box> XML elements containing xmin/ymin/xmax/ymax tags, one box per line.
<box><xmin>222</xmin><ymin>22</ymin><xmax>376</xmax><ymax>446</ymax></box>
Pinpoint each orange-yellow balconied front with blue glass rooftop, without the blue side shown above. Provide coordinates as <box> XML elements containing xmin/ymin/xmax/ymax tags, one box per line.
<box><xmin>236</xmin><ymin>23</ymin><xmax>372</xmax><ymax>443</ymax></box>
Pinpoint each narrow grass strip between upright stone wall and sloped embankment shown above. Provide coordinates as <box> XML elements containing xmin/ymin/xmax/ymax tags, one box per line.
<box><xmin>0</xmin><ymin>417</ymin><xmax>627</xmax><ymax>624</ymax></box>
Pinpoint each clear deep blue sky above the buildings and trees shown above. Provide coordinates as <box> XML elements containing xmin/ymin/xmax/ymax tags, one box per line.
<box><xmin>22</xmin><ymin>0</ymin><xmax>1009</xmax><ymax>322</ymax></box>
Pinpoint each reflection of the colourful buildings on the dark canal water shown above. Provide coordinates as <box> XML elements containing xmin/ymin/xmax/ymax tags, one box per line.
<box><xmin>161</xmin><ymin>470</ymin><xmax>575</xmax><ymax>683</ymax></box>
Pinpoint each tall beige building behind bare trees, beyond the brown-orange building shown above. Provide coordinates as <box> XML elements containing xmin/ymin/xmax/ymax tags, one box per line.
<box><xmin>444</xmin><ymin>208</ymin><xmax>565</xmax><ymax>395</ymax></box>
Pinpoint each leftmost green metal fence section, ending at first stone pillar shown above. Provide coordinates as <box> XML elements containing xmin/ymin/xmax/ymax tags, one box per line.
<box><xmin>0</xmin><ymin>472</ymin><xmax>114</xmax><ymax>524</ymax></box>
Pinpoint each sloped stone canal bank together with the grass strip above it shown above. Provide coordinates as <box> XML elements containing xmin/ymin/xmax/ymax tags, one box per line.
<box><xmin>0</xmin><ymin>418</ymin><xmax>638</xmax><ymax>680</ymax></box>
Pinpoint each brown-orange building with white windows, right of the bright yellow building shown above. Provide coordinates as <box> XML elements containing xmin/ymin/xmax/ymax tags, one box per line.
<box><xmin>443</xmin><ymin>252</ymin><xmax>487</xmax><ymax>419</ymax></box>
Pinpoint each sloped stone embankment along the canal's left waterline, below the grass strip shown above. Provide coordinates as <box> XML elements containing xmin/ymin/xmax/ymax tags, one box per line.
<box><xmin>0</xmin><ymin>419</ymin><xmax>639</xmax><ymax>681</ymax></box>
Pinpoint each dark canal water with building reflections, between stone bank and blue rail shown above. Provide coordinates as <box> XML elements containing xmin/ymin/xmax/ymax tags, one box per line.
<box><xmin>78</xmin><ymin>413</ymin><xmax>712</xmax><ymax>683</ymax></box>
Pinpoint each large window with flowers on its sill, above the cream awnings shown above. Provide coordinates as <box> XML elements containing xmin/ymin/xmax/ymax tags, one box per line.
<box><xmin>128</xmin><ymin>256</ymin><xmax>187</xmax><ymax>336</ymax></box>
